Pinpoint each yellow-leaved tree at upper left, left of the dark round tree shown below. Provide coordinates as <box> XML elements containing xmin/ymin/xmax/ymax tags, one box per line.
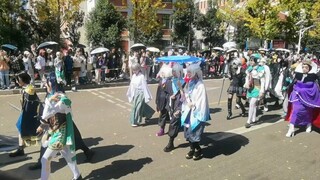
<box><xmin>27</xmin><ymin>0</ymin><xmax>83</xmax><ymax>43</ymax></box>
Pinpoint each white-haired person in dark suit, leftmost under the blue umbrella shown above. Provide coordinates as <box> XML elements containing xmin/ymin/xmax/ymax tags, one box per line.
<box><xmin>156</xmin><ymin>66</ymin><xmax>172</xmax><ymax>136</ymax></box>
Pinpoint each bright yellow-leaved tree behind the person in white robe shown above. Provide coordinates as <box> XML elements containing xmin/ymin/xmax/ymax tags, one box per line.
<box><xmin>128</xmin><ymin>0</ymin><xmax>164</xmax><ymax>45</ymax></box>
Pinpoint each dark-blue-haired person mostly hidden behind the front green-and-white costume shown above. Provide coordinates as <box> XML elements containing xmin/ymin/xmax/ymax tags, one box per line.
<box><xmin>29</xmin><ymin>73</ymin><xmax>94</xmax><ymax>170</ymax></box>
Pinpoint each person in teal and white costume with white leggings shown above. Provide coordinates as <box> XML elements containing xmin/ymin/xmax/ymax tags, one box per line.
<box><xmin>244</xmin><ymin>56</ymin><xmax>266</xmax><ymax>128</ymax></box>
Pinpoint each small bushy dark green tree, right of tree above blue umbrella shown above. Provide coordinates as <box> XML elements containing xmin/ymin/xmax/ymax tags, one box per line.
<box><xmin>195</xmin><ymin>8</ymin><xmax>224</xmax><ymax>48</ymax></box>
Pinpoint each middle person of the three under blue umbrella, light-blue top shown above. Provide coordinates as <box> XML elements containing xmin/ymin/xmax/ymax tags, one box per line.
<box><xmin>163</xmin><ymin>64</ymin><xmax>185</xmax><ymax>152</ymax></box>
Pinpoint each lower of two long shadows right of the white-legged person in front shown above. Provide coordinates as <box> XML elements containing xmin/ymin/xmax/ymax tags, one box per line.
<box><xmin>84</xmin><ymin>157</ymin><xmax>152</xmax><ymax>179</ymax></box>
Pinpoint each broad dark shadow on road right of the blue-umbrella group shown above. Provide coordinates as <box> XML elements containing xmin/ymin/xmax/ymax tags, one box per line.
<box><xmin>200</xmin><ymin>132</ymin><xmax>249</xmax><ymax>159</ymax></box>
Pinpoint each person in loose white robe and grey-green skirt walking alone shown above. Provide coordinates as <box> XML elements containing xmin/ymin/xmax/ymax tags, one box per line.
<box><xmin>127</xmin><ymin>63</ymin><xmax>154</xmax><ymax>127</ymax></box>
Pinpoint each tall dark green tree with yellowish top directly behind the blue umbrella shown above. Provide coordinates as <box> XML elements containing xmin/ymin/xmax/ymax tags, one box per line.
<box><xmin>172</xmin><ymin>0</ymin><xmax>200</xmax><ymax>50</ymax></box>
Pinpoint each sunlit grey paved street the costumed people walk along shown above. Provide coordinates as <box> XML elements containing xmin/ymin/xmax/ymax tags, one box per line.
<box><xmin>0</xmin><ymin>79</ymin><xmax>320</xmax><ymax>180</ymax></box>
